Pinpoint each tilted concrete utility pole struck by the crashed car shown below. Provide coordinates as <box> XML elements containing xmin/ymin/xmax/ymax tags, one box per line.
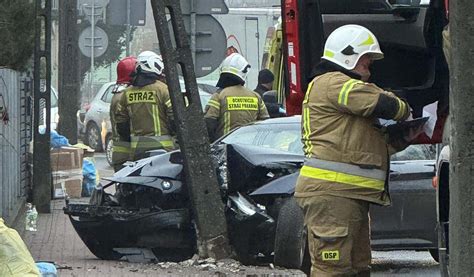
<box><xmin>151</xmin><ymin>0</ymin><xmax>230</xmax><ymax>259</ymax></box>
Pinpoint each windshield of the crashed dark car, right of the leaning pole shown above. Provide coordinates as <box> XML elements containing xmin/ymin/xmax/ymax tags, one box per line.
<box><xmin>222</xmin><ymin>123</ymin><xmax>303</xmax><ymax>155</ymax></box>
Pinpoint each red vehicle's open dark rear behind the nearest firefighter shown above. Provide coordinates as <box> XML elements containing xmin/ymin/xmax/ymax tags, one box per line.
<box><xmin>282</xmin><ymin>0</ymin><xmax>449</xmax><ymax>143</ymax></box>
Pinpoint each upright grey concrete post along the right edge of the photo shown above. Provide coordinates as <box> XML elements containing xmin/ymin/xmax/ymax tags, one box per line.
<box><xmin>449</xmin><ymin>0</ymin><xmax>474</xmax><ymax>276</ymax></box>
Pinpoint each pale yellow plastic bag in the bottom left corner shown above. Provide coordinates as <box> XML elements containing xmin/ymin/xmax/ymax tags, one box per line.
<box><xmin>0</xmin><ymin>218</ymin><xmax>41</xmax><ymax>277</ymax></box>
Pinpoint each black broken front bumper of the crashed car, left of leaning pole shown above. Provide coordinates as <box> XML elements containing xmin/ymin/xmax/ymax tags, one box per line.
<box><xmin>64</xmin><ymin>204</ymin><xmax>196</xmax><ymax>260</ymax></box>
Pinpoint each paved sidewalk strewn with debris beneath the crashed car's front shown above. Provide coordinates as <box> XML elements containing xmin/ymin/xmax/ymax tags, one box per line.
<box><xmin>16</xmin><ymin>200</ymin><xmax>305</xmax><ymax>277</ymax></box>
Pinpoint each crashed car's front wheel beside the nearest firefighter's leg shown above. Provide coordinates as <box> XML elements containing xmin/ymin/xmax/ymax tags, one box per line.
<box><xmin>274</xmin><ymin>198</ymin><xmax>309</xmax><ymax>269</ymax></box>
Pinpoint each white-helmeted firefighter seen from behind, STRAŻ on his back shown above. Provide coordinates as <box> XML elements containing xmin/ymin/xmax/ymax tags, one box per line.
<box><xmin>116</xmin><ymin>51</ymin><xmax>176</xmax><ymax>161</ymax></box>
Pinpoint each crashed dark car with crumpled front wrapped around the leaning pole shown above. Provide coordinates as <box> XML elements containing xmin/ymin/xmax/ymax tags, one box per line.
<box><xmin>65</xmin><ymin>116</ymin><xmax>437</xmax><ymax>269</ymax></box>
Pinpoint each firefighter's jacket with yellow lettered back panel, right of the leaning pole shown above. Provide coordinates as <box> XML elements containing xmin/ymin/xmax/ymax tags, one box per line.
<box><xmin>204</xmin><ymin>85</ymin><xmax>269</xmax><ymax>138</ymax></box>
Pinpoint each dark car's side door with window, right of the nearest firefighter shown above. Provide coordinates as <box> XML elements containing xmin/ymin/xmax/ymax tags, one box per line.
<box><xmin>370</xmin><ymin>145</ymin><xmax>437</xmax><ymax>249</ymax></box>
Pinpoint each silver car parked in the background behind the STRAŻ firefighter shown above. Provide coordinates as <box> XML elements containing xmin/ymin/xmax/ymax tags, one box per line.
<box><xmin>82</xmin><ymin>82</ymin><xmax>215</xmax><ymax>158</ymax></box>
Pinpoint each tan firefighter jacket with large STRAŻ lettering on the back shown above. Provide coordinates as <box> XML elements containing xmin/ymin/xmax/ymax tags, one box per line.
<box><xmin>116</xmin><ymin>78</ymin><xmax>175</xmax><ymax>160</ymax></box>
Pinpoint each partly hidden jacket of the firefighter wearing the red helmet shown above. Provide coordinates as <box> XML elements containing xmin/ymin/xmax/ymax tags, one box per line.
<box><xmin>110</xmin><ymin>89</ymin><xmax>131</xmax><ymax>167</ymax></box>
